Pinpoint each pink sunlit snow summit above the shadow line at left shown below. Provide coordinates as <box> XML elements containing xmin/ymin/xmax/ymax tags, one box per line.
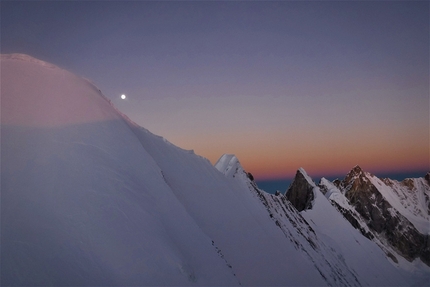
<box><xmin>1</xmin><ymin>54</ymin><xmax>121</xmax><ymax>128</ymax></box>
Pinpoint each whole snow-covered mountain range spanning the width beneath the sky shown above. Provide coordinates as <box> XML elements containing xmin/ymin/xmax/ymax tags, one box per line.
<box><xmin>1</xmin><ymin>54</ymin><xmax>430</xmax><ymax>286</ymax></box>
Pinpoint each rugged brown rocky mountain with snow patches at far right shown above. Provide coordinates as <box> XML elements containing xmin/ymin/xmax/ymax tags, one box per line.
<box><xmin>320</xmin><ymin>166</ymin><xmax>430</xmax><ymax>270</ymax></box>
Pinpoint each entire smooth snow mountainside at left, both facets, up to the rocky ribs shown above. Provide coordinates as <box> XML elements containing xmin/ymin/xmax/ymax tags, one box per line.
<box><xmin>1</xmin><ymin>55</ymin><xmax>325</xmax><ymax>286</ymax></box>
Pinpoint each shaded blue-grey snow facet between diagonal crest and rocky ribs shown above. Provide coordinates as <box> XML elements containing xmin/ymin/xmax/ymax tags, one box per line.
<box><xmin>126</xmin><ymin>139</ymin><xmax>326</xmax><ymax>286</ymax></box>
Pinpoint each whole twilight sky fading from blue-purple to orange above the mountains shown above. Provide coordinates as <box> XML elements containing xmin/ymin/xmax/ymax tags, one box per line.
<box><xmin>1</xmin><ymin>1</ymin><xmax>430</xmax><ymax>179</ymax></box>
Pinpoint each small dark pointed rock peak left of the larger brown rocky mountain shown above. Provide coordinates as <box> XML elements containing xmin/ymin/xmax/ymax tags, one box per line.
<box><xmin>285</xmin><ymin>168</ymin><xmax>315</xmax><ymax>211</ymax></box>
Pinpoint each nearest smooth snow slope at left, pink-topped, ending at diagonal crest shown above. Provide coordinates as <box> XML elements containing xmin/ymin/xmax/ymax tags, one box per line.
<box><xmin>1</xmin><ymin>55</ymin><xmax>239</xmax><ymax>286</ymax></box>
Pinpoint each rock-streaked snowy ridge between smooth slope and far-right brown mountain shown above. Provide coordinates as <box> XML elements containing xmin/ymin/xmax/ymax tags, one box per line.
<box><xmin>216</xmin><ymin>160</ymin><xmax>430</xmax><ymax>286</ymax></box>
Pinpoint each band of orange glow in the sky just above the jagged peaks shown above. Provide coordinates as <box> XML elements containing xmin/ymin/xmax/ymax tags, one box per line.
<box><xmin>166</xmin><ymin>124</ymin><xmax>429</xmax><ymax>180</ymax></box>
